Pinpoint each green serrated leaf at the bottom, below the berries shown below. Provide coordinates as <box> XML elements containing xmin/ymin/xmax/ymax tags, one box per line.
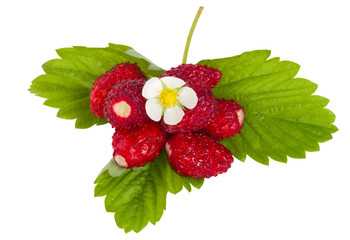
<box><xmin>95</xmin><ymin>151</ymin><xmax>204</xmax><ymax>232</ymax></box>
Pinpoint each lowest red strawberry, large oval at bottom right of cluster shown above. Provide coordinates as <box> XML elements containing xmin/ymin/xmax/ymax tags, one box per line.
<box><xmin>165</xmin><ymin>133</ymin><xmax>233</xmax><ymax>178</ymax></box>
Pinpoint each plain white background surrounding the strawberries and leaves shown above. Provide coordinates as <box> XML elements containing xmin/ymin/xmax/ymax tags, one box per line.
<box><xmin>0</xmin><ymin>0</ymin><xmax>350</xmax><ymax>240</ymax></box>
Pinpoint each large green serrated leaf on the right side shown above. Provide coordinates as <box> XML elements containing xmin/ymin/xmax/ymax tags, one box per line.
<box><xmin>198</xmin><ymin>50</ymin><xmax>337</xmax><ymax>165</ymax></box>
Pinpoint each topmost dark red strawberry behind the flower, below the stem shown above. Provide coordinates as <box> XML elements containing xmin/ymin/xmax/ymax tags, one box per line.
<box><xmin>160</xmin><ymin>64</ymin><xmax>222</xmax><ymax>88</ymax></box>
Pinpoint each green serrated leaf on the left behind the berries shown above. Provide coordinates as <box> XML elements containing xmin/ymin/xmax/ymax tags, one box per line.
<box><xmin>29</xmin><ymin>44</ymin><xmax>164</xmax><ymax>128</ymax></box>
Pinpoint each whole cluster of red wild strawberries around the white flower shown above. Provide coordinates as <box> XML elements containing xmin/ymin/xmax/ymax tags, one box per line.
<box><xmin>90</xmin><ymin>62</ymin><xmax>244</xmax><ymax>178</ymax></box>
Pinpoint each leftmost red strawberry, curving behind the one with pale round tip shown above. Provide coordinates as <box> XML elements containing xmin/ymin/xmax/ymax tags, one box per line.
<box><xmin>90</xmin><ymin>62</ymin><xmax>145</xmax><ymax>118</ymax></box>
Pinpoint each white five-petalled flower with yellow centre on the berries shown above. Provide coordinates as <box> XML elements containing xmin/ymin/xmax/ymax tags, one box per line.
<box><xmin>142</xmin><ymin>77</ymin><xmax>198</xmax><ymax>125</ymax></box>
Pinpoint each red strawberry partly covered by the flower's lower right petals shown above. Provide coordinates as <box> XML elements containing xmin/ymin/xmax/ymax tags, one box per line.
<box><xmin>164</xmin><ymin>85</ymin><xmax>216</xmax><ymax>133</ymax></box>
